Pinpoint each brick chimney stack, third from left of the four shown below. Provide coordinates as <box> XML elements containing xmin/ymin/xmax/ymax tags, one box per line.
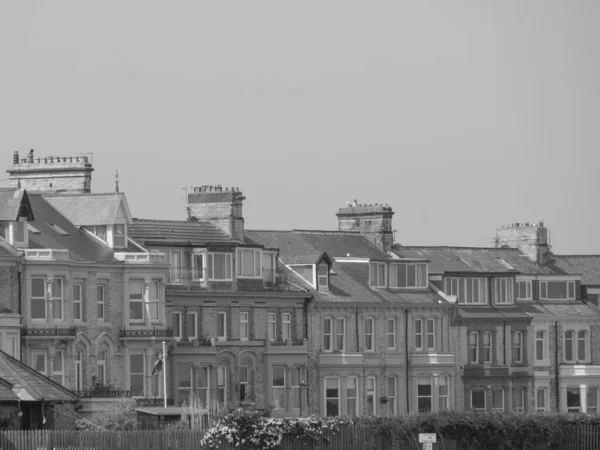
<box><xmin>336</xmin><ymin>200</ymin><xmax>394</xmax><ymax>253</ymax></box>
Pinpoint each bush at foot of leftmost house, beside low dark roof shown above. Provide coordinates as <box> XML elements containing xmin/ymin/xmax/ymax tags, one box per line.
<box><xmin>76</xmin><ymin>397</ymin><xmax>137</xmax><ymax>431</ymax></box>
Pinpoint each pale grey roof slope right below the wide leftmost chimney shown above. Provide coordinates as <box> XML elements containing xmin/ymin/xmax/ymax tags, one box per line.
<box><xmin>43</xmin><ymin>193</ymin><xmax>131</xmax><ymax>226</ymax></box>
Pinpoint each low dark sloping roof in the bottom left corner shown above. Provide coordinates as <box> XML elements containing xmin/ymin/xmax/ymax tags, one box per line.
<box><xmin>0</xmin><ymin>351</ymin><xmax>78</xmax><ymax>402</ymax></box>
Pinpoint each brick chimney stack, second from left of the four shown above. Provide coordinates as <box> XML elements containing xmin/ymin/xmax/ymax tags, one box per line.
<box><xmin>188</xmin><ymin>185</ymin><xmax>246</xmax><ymax>241</ymax></box>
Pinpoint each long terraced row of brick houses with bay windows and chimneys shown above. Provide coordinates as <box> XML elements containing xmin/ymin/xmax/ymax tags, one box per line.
<box><xmin>0</xmin><ymin>151</ymin><xmax>600</xmax><ymax>428</ymax></box>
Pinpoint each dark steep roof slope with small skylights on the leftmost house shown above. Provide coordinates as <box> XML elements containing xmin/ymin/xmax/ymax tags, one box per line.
<box><xmin>29</xmin><ymin>194</ymin><xmax>116</xmax><ymax>262</ymax></box>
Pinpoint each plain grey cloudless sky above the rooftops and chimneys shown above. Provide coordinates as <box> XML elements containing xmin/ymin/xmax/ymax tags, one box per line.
<box><xmin>0</xmin><ymin>0</ymin><xmax>600</xmax><ymax>254</ymax></box>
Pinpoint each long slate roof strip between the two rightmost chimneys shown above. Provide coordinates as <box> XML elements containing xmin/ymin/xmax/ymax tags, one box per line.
<box><xmin>393</xmin><ymin>245</ymin><xmax>560</xmax><ymax>275</ymax></box>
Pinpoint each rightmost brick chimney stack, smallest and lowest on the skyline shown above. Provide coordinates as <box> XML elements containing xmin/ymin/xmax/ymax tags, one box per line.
<box><xmin>496</xmin><ymin>222</ymin><xmax>550</xmax><ymax>264</ymax></box>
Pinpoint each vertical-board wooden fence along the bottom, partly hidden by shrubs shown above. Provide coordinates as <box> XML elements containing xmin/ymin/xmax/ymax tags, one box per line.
<box><xmin>0</xmin><ymin>426</ymin><xmax>600</xmax><ymax>450</ymax></box>
